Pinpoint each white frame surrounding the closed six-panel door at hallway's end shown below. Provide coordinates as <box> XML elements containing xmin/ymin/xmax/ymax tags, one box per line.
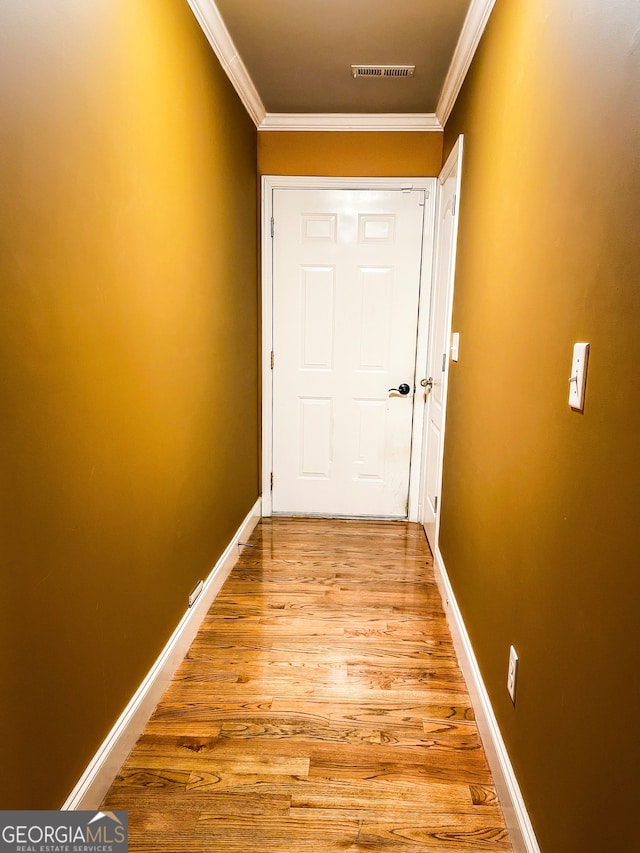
<box><xmin>262</xmin><ymin>175</ymin><xmax>437</xmax><ymax>521</ymax></box>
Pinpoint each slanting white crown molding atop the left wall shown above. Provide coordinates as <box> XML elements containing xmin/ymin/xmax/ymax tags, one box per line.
<box><xmin>187</xmin><ymin>0</ymin><xmax>266</xmax><ymax>127</ymax></box>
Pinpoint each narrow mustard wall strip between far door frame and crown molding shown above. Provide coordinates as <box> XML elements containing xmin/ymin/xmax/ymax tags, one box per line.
<box><xmin>258</xmin><ymin>131</ymin><xmax>443</xmax><ymax>178</ymax></box>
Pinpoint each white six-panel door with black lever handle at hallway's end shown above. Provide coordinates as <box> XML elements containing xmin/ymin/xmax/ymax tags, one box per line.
<box><xmin>272</xmin><ymin>189</ymin><xmax>425</xmax><ymax>518</ymax></box>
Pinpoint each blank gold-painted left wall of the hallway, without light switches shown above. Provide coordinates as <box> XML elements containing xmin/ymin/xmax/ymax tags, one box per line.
<box><xmin>0</xmin><ymin>0</ymin><xmax>259</xmax><ymax>809</ymax></box>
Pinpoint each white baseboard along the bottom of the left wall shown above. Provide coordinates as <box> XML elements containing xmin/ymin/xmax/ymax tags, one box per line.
<box><xmin>62</xmin><ymin>498</ymin><xmax>261</xmax><ymax>811</ymax></box>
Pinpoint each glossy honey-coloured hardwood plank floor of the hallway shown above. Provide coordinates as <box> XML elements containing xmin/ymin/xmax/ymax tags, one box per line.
<box><xmin>102</xmin><ymin>518</ymin><xmax>511</xmax><ymax>853</ymax></box>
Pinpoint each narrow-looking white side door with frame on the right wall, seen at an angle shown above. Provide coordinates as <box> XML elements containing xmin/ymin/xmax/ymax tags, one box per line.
<box><xmin>422</xmin><ymin>137</ymin><xmax>462</xmax><ymax>550</ymax></box>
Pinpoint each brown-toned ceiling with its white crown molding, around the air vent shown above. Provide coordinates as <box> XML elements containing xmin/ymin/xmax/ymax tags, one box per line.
<box><xmin>188</xmin><ymin>0</ymin><xmax>495</xmax><ymax>130</ymax></box>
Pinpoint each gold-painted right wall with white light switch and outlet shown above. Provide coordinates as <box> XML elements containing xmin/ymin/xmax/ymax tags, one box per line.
<box><xmin>441</xmin><ymin>0</ymin><xmax>640</xmax><ymax>853</ymax></box>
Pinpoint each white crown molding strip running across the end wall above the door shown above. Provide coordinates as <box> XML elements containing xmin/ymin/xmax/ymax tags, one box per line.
<box><xmin>258</xmin><ymin>113</ymin><xmax>442</xmax><ymax>132</ymax></box>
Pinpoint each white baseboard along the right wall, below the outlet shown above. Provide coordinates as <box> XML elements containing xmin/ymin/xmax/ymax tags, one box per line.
<box><xmin>433</xmin><ymin>548</ymin><xmax>540</xmax><ymax>853</ymax></box>
